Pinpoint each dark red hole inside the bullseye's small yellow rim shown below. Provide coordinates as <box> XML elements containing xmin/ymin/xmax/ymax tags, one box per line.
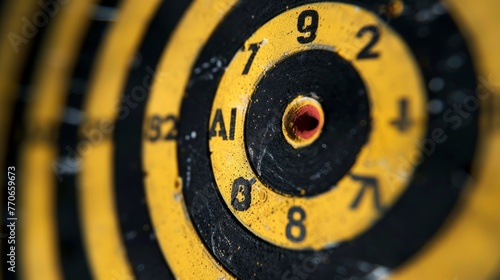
<box><xmin>293</xmin><ymin>105</ymin><xmax>320</xmax><ymax>139</ymax></box>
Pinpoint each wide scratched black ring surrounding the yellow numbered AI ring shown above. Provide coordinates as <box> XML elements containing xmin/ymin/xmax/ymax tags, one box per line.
<box><xmin>178</xmin><ymin>0</ymin><xmax>478</xmax><ymax>279</ymax></box>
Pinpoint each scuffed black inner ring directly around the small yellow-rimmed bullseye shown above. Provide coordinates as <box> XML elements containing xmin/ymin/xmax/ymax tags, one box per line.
<box><xmin>245</xmin><ymin>50</ymin><xmax>371</xmax><ymax>197</ymax></box>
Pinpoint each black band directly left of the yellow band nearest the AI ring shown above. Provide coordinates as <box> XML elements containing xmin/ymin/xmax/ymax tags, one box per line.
<box><xmin>113</xmin><ymin>0</ymin><xmax>191</xmax><ymax>279</ymax></box>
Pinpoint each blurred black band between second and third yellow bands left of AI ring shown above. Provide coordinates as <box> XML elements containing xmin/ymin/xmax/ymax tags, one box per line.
<box><xmin>56</xmin><ymin>4</ymin><xmax>120</xmax><ymax>279</ymax></box>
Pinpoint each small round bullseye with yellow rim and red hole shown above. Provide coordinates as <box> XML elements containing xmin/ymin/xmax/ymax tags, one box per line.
<box><xmin>282</xmin><ymin>96</ymin><xmax>324</xmax><ymax>148</ymax></box>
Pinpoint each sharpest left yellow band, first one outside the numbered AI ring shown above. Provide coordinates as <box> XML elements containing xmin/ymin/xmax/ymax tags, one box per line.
<box><xmin>143</xmin><ymin>0</ymin><xmax>236</xmax><ymax>279</ymax></box>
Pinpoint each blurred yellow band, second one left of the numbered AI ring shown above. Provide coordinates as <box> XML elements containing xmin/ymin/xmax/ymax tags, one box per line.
<box><xmin>77</xmin><ymin>0</ymin><xmax>160</xmax><ymax>279</ymax></box>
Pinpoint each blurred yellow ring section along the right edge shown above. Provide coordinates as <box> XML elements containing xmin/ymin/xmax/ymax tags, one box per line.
<box><xmin>390</xmin><ymin>0</ymin><xmax>500</xmax><ymax>280</ymax></box>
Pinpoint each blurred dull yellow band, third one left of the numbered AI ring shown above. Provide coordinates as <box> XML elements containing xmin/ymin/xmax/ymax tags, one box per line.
<box><xmin>17</xmin><ymin>0</ymin><xmax>93</xmax><ymax>279</ymax></box>
